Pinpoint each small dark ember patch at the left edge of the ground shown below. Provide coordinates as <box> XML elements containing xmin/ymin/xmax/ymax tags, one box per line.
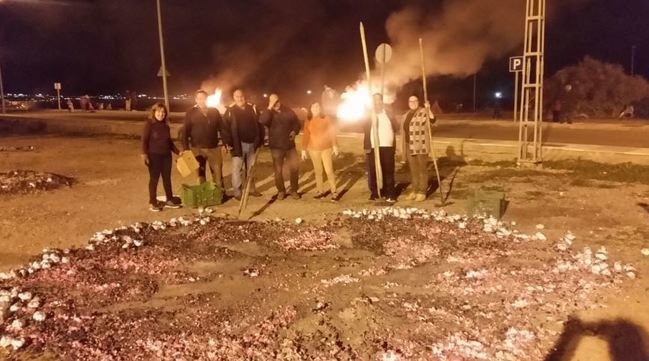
<box><xmin>0</xmin><ymin>170</ymin><xmax>74</xmax><ymax>194</ymax></box>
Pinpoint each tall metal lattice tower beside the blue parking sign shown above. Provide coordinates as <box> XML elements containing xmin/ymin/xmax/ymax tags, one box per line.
<box><xmin>518</xmin><ymin>0</ymin><xmax>546</xmax><ymax>166</ymax></box>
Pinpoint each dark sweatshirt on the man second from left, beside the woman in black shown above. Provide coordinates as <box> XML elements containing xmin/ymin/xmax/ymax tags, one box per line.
<box><xmin>182</xmin><ymin>106</ymin><xmax>223</xmax><ymax>150</ymax></box>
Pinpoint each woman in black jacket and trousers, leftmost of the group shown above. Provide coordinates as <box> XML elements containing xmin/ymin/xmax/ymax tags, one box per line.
<box><xmin>142</xmin><ymin>103</ymin><xmax>181</xmax><ymax>212</ymax></box>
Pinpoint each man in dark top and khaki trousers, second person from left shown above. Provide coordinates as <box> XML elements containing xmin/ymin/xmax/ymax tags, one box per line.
<box><xmin>182</xmin><ymin>90</ymin><xmax>223</xmax><ymax>187</ymax></box>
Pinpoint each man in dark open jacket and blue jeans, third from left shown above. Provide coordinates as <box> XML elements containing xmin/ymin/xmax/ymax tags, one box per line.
<box><xmin>223</xmin><ymin>89</ymin><xmax>264</xmax><ymax>200</ymax></box>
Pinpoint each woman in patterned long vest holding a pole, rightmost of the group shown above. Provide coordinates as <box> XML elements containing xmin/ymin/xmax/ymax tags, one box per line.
<box><xmin>401</xmin><ymin>95</ymin><xmax>435</xmax><ymax>202</ymax></box>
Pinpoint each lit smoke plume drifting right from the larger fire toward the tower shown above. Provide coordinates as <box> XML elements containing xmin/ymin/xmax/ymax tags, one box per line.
<box><xmin>386</xmin><ymin>0</ymin><xmax>588</xmax><ymax>88</ymax></box>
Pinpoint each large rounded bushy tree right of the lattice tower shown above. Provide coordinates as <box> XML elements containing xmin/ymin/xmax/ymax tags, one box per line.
<box><xmin>545</xmin><ymin>56</ymin><xmax>649</xmax><ymax>117</ymax></box>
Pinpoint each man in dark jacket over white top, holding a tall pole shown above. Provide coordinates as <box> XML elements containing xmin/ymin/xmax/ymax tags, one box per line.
<box><xmin>363</xmin><ymin>93</ymin><xmax>399</xmax><ymax>203</ymax></box>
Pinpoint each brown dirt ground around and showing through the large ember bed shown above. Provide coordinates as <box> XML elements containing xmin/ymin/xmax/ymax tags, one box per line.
<box><xmin>0</xmin><ymin>135</ymin><xmax>649</xmax><ymax>361</ymax></box>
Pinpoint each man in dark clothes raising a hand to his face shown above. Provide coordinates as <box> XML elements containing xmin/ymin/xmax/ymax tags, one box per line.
<box><xmin>260</xmin><ymin>94</ymin><xmax>301</xmax><ymax>199</ymax></box>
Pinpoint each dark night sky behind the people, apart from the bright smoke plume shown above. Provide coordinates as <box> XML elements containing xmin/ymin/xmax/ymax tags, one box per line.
<box><xmin>0</xmin><ymin>0</ymin><xmax>649</xmax><ymax>106</ymax></box>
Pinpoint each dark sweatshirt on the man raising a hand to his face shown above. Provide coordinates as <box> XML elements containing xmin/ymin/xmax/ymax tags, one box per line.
<box><xmin>259</xmin><ymin>105</ymin><xmax>302</xmax><ymax>150</ymax></box>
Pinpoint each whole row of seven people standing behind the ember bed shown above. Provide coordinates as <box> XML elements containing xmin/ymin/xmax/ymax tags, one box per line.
<box><xmin>142</xmin><ymin>89</ymin><xmax>435</xmax><ymax>211</ymax></box>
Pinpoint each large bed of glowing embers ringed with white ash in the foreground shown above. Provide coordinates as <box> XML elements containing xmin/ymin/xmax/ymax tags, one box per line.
<box><xmin>0</xmin><ymin>208</ymin><xmax>637</xmax><ymax>360</ymax></box>
